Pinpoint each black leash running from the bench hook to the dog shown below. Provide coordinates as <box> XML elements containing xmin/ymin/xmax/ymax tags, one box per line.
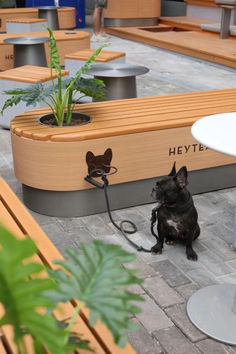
<box><xmin>85</xmin><ymin>166</ymin><xmax>158</xmax><ymax>253</ymax></box>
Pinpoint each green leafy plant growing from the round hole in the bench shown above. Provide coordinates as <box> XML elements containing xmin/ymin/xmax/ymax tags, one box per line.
<box><xmin>1</xmin><ymin>28</ymin><xmax>106</xmax><ymax>126</ymax></box>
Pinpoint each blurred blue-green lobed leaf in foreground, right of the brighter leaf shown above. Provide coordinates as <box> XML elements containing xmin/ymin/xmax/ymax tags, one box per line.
<box><xmin>47</xmin><ymin>240</ymin><xmax>143</xmax><ymax>346</ymax></box>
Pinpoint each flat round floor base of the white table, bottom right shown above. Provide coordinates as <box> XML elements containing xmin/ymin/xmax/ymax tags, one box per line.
<box><xmin>187</xmin><ymin>284</ymin><xmax>236</xmax><ymax>345</ymax></box>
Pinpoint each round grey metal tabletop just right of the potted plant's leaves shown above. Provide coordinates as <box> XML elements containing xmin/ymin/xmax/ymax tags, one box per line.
<box><xmin>86</xmin><ymin>63</ymin><xmax>149</xmax><ymax>77</ymax></box>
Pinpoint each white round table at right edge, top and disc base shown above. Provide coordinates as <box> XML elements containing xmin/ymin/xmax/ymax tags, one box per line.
<box><xmin>187</xmin><ymin>112</ymin><xmax>236</xmax><ymax>345</ymax></box>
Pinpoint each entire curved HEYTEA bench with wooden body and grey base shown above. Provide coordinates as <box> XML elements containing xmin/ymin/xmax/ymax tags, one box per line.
<box><xmin>11</xmin><ymin>89</ymin><xmax>236</xmax><ymax>216</ymax></box>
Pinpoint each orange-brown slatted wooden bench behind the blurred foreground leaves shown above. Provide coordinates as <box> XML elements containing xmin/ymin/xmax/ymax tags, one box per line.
<box><xmin>0</xmin><ymin>178</ymin><xmax>135</xmax><ymax>354</ymax></box>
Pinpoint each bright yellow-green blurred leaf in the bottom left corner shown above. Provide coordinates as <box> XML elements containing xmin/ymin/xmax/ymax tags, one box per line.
<box><xmin>0</xmin><ymin>225</ymin><xmax>73</xmax><ymax>354</ymax></box>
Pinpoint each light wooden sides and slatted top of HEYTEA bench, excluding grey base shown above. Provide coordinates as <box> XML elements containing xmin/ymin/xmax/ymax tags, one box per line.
<box><xmin>11</xmin><ymin>89</ymin><xmax>236</xmax><ymax>191</ymax></box>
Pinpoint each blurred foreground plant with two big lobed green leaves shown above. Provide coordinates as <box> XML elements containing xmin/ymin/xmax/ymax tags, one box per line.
<box><xmin>0</xmin><ymin>225</ymin><xmax>143</xmax><ymax>354</ymax></box>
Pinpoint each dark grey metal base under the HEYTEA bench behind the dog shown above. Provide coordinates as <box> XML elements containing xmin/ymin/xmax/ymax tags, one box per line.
<box><xmin>23</xmin><ymin>164</ymin><xmax>236</xmax><ymax>217</ymax></box>
